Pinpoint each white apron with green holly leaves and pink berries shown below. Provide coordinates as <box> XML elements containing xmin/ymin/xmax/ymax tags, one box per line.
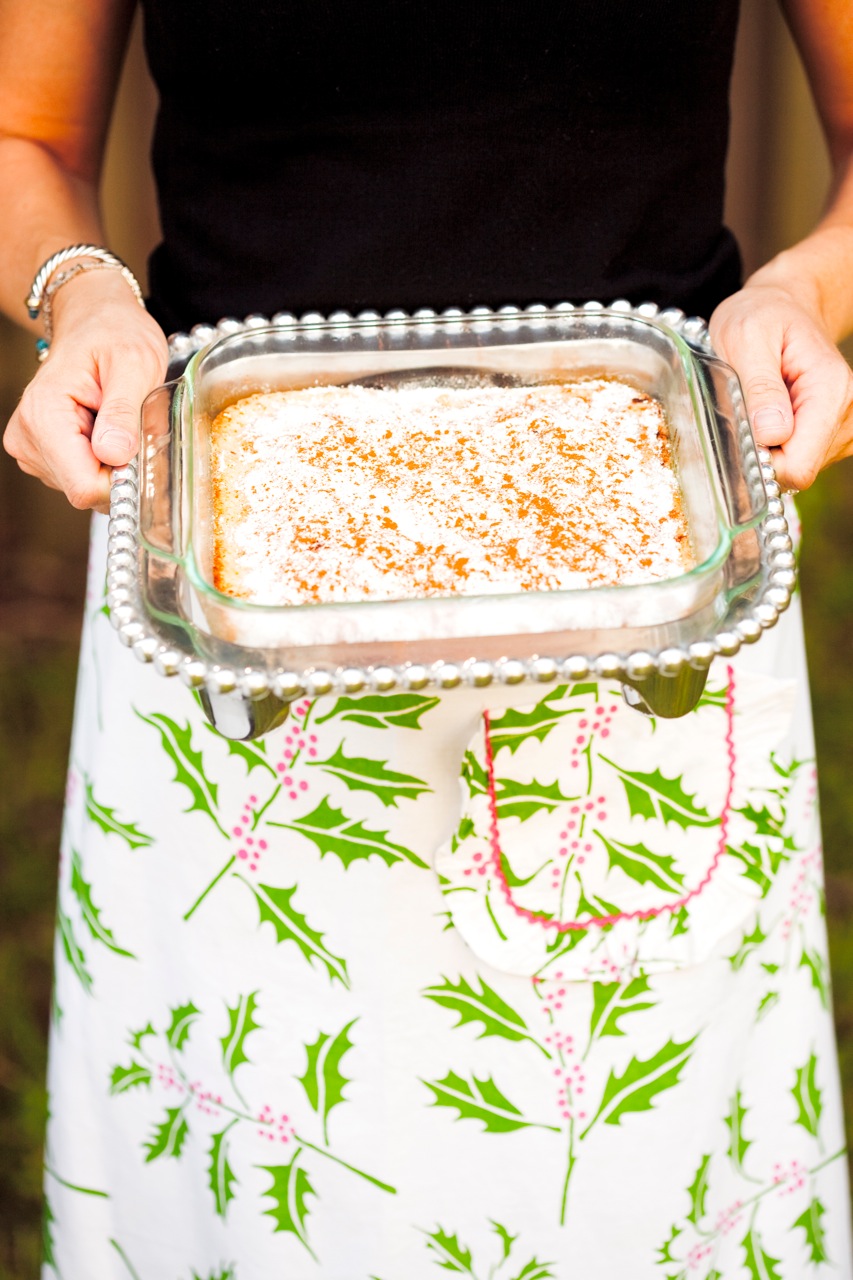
<box><xmin>42</xmin><ymin>518</ymin><xmax>853</xmax><ymax>1280</ymax></box>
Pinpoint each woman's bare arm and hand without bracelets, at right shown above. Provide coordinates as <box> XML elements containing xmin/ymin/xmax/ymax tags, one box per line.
<box><xmin>711</xmin><ymin>0</ymin><xmax>853</xmax><ymax>489</ymax></box>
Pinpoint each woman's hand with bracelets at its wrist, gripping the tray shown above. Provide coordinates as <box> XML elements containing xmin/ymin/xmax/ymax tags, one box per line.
<box><xmin>3</xmin><ymin>270</ymin><xmax>168</xmax><ymax>511</ymax></box>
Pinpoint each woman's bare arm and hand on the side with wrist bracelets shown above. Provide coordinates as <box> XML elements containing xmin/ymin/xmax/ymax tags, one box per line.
<box><xmin>0</xmin><ymin>0</ymin><xmax>165</xmax><ymax>509</ymax></box>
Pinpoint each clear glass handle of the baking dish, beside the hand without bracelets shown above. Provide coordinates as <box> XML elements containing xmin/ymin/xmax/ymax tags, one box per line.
<box><xmin>694</xmin><ymin>352</ymin><xmax>767</xmax><ymax>529</ymax></box>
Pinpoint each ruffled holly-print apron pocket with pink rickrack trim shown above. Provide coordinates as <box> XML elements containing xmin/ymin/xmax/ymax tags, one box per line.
<box><xmin>435</xmin><ymin>664</ymin><xmax>795</xmax><ymax>982</ymax></box>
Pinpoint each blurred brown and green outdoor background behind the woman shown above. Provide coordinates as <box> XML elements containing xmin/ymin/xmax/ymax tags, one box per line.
<box><xmin>0</xmin><ymin>0</ymin><xmax>853</xmax><ymax>1280</ymax></box>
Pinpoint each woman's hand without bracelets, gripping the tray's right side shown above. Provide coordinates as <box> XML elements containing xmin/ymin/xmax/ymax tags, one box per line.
<box><xmin>711</xmin><ymin>282</ymin><xmax>853</xmax><ymax>489</ymax></box>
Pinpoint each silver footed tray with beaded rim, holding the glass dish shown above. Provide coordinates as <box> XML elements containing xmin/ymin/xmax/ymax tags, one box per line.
<box><xmin>108</xmin><ymin>302</ymin><xmax>795</xmax><ymax>739</ymax></box>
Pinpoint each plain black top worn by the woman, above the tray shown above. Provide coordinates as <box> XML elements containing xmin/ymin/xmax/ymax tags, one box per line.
<box><xmin>137</xmin><ymin>0</ymin><xmax>740</xmax><ymax>330</ymax></box>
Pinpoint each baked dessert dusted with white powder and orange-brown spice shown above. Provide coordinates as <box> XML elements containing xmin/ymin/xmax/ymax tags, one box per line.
<box><xmin>210</xmin><ymin>378</ymin><xmax>693</xmax><ymax>605</ymax></box>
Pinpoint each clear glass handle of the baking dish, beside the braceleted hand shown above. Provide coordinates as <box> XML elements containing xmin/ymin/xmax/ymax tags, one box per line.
<box><xmin>140</xmin><ymin>378</ymin><xmax>183</xmax><ymax>559</ymax></box>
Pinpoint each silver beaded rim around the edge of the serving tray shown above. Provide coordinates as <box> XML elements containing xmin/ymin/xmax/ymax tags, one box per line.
<box><xmin>106</xmin><ymin>300</ymin><xmax>797</xmax><ymax>727</ymax></box>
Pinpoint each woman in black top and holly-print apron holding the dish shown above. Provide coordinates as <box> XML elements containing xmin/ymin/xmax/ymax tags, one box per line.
<box><xmin>0</xmin><ymin>0</ymin><xmax>853</xmax><ymax>1280</ymax></box>
